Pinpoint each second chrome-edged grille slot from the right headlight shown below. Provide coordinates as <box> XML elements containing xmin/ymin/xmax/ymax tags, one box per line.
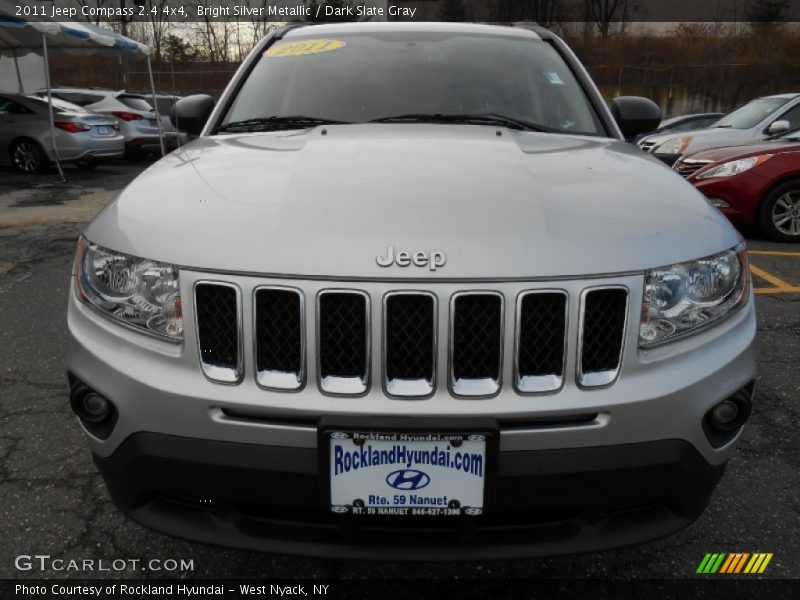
<box><xmin>515</xmin><ymin>291</ymin><xmax>567</xmax><ymax>393</ymax></box>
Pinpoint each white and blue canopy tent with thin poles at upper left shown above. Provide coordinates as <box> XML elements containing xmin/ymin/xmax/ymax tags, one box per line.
<box><xmin>0</xmin><ymin>0</ymin><xmax>164</xmax><ymax>180</ymax></box>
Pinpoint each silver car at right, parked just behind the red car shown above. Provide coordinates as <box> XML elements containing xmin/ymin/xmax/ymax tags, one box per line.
<box><xmin>638</xmin><ymin>94</ymin><xmax>800</xmax><ymax>165</ymax></box>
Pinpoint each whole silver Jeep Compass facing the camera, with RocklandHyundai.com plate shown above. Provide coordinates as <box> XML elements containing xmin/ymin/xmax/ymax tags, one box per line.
<box><xmin>67</xmin><ymin>23</ymin><xmax>756</xmax><ymax>558</ymax></box>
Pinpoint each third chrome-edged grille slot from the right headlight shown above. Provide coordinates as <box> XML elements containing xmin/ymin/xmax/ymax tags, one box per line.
<box><xmin>450</xmin><ymin>292</ymin><xmax>503</xmax><ymax>397</ymax></box>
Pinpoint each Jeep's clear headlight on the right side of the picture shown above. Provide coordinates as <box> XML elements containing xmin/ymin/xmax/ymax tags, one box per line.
<box><xmin>639</xmin><ymin>244</ymin><xmax>750</xmax><ymax>348</ymax></box>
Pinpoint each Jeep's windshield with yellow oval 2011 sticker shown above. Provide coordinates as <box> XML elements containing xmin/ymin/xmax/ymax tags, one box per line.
<box><xmin>223</xmin><ymin>31</ymin><xmax>605</xmax><ymax>135</ymax></box>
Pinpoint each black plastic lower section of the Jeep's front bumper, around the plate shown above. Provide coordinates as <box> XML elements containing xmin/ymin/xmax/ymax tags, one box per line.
<box><xmin>95</xmin><ymin>432</ymin><xmax>725</xmax><ymax>560</ymax></box>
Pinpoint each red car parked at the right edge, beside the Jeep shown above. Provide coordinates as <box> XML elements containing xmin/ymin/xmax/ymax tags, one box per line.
<box><xmin>673</xmin><ymin>130</ymin><xmax>800</xmax><ymax>242</ymax></box>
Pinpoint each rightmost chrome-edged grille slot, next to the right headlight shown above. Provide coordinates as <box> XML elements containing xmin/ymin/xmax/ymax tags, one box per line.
<box><xmin>578</xmin><ymin>287</ymin><xmax>628</xmax><ymax>387</ymax></box>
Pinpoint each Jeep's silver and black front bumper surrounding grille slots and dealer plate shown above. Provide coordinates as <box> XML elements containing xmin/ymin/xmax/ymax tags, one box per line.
<box><xmin>67</xmin><ymin>271</ymin><xmax>756</xmax><ymax>558</ymax></box>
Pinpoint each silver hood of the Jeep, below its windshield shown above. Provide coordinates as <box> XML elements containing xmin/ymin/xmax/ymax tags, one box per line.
<box><xmin>86</xmin><ymin>124</ymin><xmax>739</xmax><ymax>279</ymax></box>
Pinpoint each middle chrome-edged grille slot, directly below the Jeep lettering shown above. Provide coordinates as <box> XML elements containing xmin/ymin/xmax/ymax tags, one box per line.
<box><xmin>383</xmin><ymin>292</ymin><xmax>436</xmax><ymax>398</ymax></box>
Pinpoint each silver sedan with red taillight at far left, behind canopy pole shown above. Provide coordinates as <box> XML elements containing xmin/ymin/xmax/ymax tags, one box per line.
<box><xmin>0</xmin><ymin>94</ymin><xmax>125</xmax><ymax>173</ymax></box>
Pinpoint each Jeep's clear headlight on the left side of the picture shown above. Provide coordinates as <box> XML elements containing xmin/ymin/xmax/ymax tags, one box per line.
<box><xmin>75</xmin><ymin>238</ymin><xmax>183</xmax><ymax>341</ymax></box>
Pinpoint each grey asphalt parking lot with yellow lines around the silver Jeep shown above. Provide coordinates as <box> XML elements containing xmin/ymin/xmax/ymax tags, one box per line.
<box><xmin>0</xmin><ymin>163</ymin><xmax>800</xmax><ymax>579</ymax></box>
